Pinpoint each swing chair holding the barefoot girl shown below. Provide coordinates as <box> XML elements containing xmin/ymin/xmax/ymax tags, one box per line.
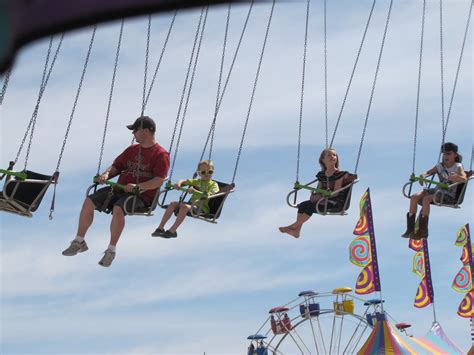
<box><xmin>286</xmin><ymin>173</ymin><xmax>359</xmax><ymax>216</ymax></box>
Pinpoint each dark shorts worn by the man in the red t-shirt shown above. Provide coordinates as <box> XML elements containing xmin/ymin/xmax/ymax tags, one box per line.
<box><xmin>88</xmin><ymin>186</ymin><xmax>147</xmax><ymax>214</ymax></box>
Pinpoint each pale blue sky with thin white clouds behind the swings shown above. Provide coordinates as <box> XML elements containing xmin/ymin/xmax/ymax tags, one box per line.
<box><xmin>0</xmin><ymin>0</ymin><xmax>473</xmax><ymax>354</ymax></box>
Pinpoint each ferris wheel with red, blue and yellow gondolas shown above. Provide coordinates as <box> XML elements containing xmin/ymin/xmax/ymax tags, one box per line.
<box><xmin>247</xmin><ymin>287</ymin><xmax>384</xmax><ymax>355</ymax></box>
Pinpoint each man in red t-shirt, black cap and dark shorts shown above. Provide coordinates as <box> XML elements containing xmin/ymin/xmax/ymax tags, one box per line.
<box><xmin>63</xmin><ymin>116</ymin><xmax>170</xmax><ymax>267</ymax></box>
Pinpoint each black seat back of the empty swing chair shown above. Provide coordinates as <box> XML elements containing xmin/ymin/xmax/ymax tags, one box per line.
<box><xmin>5</xmin><ymin>170</ymin><xmax>52</xmax><ymax>212</ymax></box>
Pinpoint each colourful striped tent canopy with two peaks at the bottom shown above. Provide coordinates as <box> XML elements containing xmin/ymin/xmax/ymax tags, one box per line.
<box><xmin>357</xmin><ymin>320</ymin><xmax>464</xmax><ymax>355</ymax></box>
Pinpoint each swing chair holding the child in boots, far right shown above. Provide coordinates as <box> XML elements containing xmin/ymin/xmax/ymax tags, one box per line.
<box><xmin>402</xmin><ymin>170</ymin><xmax>474</xmax><ymax>208</ymax></box>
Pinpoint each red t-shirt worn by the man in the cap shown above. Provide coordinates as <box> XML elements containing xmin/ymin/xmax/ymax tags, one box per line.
<box><xmin>112</xmin><ymin>143</ymin><xmax>170</xmax><ymax>203</ymax></box>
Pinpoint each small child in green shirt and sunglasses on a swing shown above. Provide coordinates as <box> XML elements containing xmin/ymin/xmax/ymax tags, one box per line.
<box><xmin>152</xmin><ymin>160</ymin><xmax>219</xmax><ymax>238</ymax></box>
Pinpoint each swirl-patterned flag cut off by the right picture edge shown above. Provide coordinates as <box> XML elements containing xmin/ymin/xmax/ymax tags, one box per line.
<box><xmin>452</xmin><ymin>224</ymin><xmax>474</xmax><ymax>318</ymax></box>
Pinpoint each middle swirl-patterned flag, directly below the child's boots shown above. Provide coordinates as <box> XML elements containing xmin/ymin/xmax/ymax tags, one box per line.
<box><xmin>408</xmin><ymin>239</ymin><xmax>434</xmax><ymax>308</ymax></box>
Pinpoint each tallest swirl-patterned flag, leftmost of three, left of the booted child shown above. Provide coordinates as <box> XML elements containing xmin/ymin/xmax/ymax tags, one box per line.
<box><xmin>349</xmin><ymin>189</ymin><xmax>381</xmax><ymax>295</ymax></box>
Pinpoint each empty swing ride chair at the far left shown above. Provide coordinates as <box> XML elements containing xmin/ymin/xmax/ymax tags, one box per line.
<box><xmin>0</xmin><ymin>163</ymin><xmax>59</xmax><ymax>217</ymax></box>
